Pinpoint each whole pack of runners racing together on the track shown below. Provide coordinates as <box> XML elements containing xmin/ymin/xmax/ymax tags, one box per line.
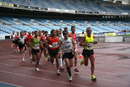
<box><xmin>11</xmin><ymin>26</ymin><xmax>97</xmax><ymax>81</ymax></box>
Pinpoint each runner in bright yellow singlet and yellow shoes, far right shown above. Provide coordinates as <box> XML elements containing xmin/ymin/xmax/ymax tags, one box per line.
<box><xmin>80</xmin><ymin>27</ymin><xmax>97</xmax><ymax>81</ymax></box>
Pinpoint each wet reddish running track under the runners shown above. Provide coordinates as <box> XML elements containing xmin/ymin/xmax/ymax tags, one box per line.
<box><xmin>0</xmin><ymin>41</ymin><xmax>130</xmax><ymax>87</ymax></box>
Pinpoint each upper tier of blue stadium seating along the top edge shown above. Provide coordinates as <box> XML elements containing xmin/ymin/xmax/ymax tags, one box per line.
<box><xmin>0</xmin><ymin>0</ymin><xmax>130</xmax><ymax>13</ymax></box>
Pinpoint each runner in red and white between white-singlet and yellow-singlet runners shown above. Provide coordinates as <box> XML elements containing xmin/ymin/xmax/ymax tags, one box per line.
<box><xmin>69</xmin><ymin>26</ymin><xmax>79</xmax><ymax>72</ymax></box>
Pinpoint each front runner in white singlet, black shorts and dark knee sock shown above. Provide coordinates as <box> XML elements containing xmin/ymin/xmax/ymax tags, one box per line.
<box><xmin>62</xmin><ymin>31</ymin><xmax>75</xmax><ymax>81</ymax></box>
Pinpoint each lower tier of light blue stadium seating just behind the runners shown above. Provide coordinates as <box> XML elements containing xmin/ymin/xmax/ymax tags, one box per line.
<box><xmin>0</xmin><ymin>17</ymin><xmax>130</xmax><ymax>34</ymax></box>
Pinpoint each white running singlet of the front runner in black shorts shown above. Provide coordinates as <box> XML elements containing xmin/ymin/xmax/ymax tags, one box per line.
<box><xmin>62</xmin><ymin>37</ymin><xmax>72</xmax><ymax>53</ymax></box>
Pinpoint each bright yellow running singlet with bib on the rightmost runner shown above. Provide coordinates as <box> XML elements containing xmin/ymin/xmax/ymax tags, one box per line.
<box><xmin>84</xmin><ymin>34</ymin><xmax>94</xmax><ymax>50</ymax></box>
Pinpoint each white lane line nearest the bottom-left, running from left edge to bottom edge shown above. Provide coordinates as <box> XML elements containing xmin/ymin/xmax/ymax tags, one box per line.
<box><xmin>0</xmin><ymin>70</ymin><xmax>89</xmax><ymax>87</ymax></box>
